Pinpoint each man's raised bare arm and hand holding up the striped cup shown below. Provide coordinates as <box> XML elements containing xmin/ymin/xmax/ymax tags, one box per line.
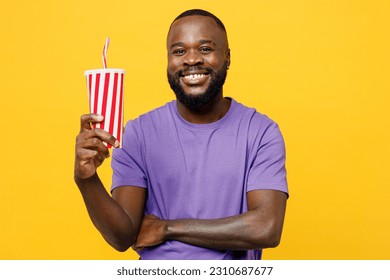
<box><xmin>74</xmin><ymin>114</ymin><xmax>146</xmax><ymax>251</ymax></box>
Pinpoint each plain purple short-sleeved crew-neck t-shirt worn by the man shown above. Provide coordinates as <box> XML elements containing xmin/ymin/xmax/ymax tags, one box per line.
<box><xmin>112</xmin><ymin>99</ymin><xmax>288</xmax><ymax>260</ymax></box>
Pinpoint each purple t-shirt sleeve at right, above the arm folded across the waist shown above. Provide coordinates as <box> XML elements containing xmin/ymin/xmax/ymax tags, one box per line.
<box><xmin>247</xmin><ymin>122</ymin><xmax>288</xmax><ymax>195</ymax></box>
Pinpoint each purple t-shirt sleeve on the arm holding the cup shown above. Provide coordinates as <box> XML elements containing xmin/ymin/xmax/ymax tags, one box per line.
<box><xmin>111</xmin><ymin>121</ymin><xmax>147</xmax><ymax>191</ymax></box>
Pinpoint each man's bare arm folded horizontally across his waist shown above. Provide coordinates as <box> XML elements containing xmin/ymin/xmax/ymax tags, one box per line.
<box><xmin>133</xmin><ymin>190</ymin><xmax>287</xmax><ymax>250</ymax></box>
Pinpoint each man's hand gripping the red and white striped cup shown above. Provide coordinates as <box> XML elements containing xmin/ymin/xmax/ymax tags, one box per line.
<box><xmin>74</xmin><ymin>114</ymin><xmax>119</xmax><ymax>182</ymax></box>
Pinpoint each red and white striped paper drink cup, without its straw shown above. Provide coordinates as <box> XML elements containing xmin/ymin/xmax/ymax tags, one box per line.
<box><xmin>84</xmin><ymin>69</ymin><xmax>125</xmax><ymax>148</ymax></box>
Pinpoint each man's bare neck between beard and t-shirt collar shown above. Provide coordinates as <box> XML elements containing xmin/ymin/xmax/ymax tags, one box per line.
<box><xmin>177</xmin><ymin>94</ymin><xmax>231</xmax><ymax>124</ymax></box>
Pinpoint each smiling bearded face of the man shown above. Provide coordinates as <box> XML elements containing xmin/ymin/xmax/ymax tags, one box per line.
<box><xmin>167</xmin><ymin>16</ymin><xmax>230</xmax><ymax>109</ymax></box>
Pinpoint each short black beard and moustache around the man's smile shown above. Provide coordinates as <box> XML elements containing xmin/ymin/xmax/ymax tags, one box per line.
<box><xmin>167</xmin><ymin>65</ymin><xmax>227</xmax><ymax>111</ymax></box>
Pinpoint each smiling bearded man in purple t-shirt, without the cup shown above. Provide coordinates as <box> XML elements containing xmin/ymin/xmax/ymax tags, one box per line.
<box><xmin>75</xmin><ymin>10</ymin><xmax>288</xmax><ymax>259</ymax></box>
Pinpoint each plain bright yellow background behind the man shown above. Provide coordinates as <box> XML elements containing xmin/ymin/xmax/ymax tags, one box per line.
<box><xmin>0</xmin><ymin>0</ymin><xmax>390</xmax><ymax>259</ymax></box>
